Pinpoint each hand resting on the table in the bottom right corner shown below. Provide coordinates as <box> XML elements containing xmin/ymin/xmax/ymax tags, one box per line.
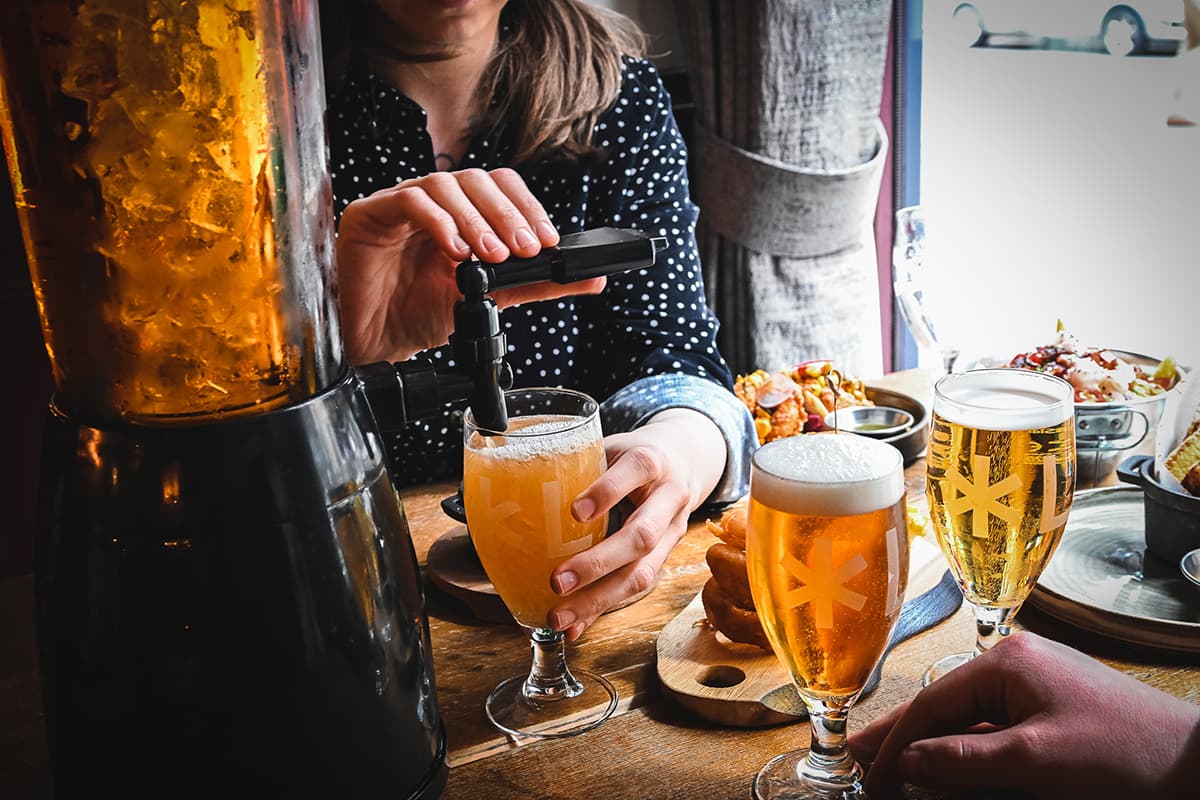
<box><xmin>850</xmin><ymin>632</ymin><xmax>1200</xmax><ymax>800</ymax></box>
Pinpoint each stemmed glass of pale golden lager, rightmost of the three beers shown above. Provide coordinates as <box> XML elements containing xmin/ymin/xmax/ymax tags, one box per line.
<box><xmin>924</xmin><ymin>369</ymin><xmax>1075</xmax><ymax>685</ymax></box>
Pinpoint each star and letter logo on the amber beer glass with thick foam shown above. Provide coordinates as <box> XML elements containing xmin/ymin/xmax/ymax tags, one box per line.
<box><xmin>780</xmin><ymin>528</ymin><xmax>900</xmax><ymax>628</ymax></box>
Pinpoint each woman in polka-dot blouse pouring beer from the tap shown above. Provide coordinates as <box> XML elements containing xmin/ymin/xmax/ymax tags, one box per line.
<box><xmin>322</xmin><ymin>0</ymin><xmax>756</xmax><ymax>639</ymax></box>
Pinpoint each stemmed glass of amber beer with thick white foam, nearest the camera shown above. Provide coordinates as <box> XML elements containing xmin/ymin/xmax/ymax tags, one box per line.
<box><xmin>746</xmin><ymin>433</ymin><xmax>908</xmax><ymax>800</ymax></box>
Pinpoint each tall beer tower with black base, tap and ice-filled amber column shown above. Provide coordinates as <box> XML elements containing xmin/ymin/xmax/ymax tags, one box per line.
<box><xmin>0</xmin><ymin>0</ymin><xmax>655</xmax><ymax>799</ymax></box>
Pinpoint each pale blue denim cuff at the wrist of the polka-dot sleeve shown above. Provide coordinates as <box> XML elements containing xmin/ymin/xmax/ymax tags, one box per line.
<box><xmin>600</xmin><ymin>373</ymin><xmax>758</xmax><ymax>505</ymax></box>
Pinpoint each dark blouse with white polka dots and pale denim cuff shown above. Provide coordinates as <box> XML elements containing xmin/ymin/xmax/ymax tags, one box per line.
<box><xmin>329</xmin><ymin>59</ymin><xmax>757</xmax><ymax>501</ymax></box>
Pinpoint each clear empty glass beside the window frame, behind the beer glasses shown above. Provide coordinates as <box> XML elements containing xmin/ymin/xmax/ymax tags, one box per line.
<box><xmin>892</xmin><ymin>205</ymin><xmax>960</xmax><ymax>373</ymax></box>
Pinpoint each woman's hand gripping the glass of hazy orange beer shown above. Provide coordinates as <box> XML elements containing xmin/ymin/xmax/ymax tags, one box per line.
<box><xmin>550</xmin><ymin>408</ymin><xmax>725</xmax><ymax>640</ymax></box>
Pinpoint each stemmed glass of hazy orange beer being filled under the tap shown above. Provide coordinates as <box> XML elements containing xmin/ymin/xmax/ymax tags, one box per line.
<box><xmin>462</xmin><ymin>389</ymin><xmax>617</xmax><ymax>738</ymax></box>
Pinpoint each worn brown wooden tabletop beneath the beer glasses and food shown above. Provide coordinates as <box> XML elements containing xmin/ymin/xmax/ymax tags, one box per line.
<box><xmin>0</xmin><ymin>371</ymin><xmax>1200</xmax><ymax>800</ymax></box>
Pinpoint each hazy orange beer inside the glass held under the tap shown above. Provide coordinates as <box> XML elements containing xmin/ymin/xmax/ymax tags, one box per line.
<box><xmin>463</xmin><ymin>415</ymin><xmax>607</xmax><ymax>627</ymax></box>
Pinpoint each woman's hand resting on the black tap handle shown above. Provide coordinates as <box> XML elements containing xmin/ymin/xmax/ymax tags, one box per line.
<box><xmin>337</xmin><ymin>169</ymin><xmax>605</xmax><ymax>363</ymax></box>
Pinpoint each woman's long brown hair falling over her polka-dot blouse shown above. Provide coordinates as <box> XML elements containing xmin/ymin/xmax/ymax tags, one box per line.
<box><xmin>320</xmin><ymin>0</ymin><xmax>647</xmax><ymax>164</ymax></box>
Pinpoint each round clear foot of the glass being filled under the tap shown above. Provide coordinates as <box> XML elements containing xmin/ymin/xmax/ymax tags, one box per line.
<box><xmin>484</xmin><ymin>669</ymin><xmax>617</xmax><ymax>739</ymax></box>
